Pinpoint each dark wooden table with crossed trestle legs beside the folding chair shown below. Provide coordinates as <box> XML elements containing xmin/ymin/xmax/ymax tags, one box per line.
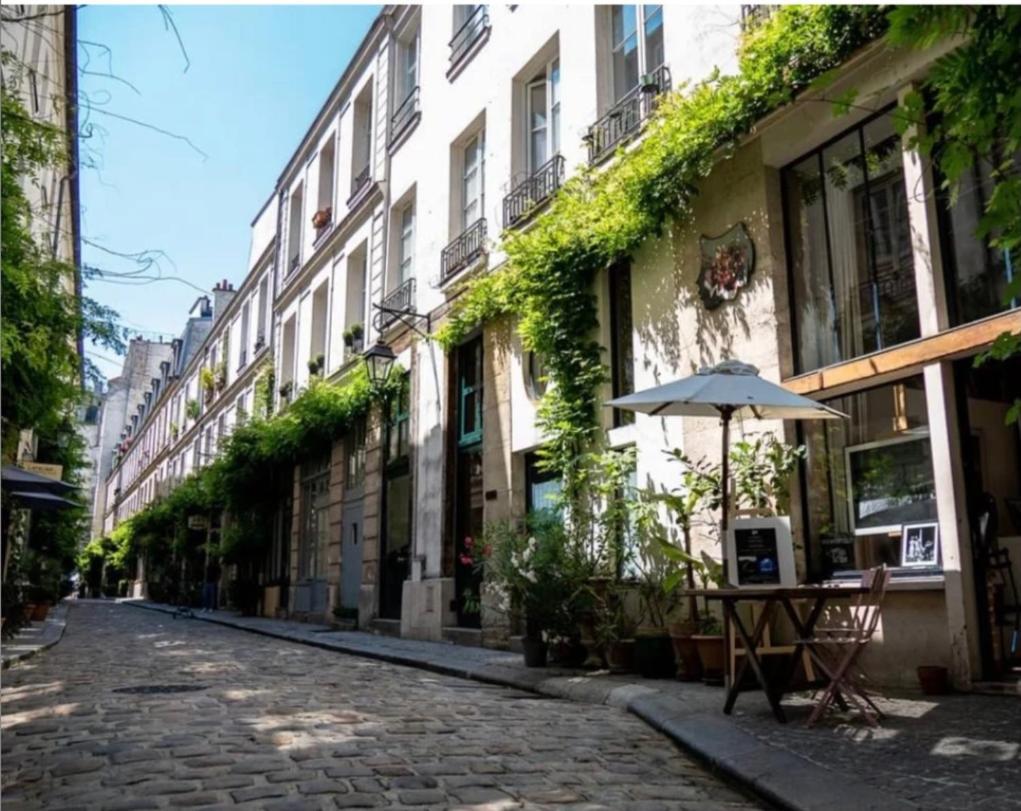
<box><xmin>685</xmin><ymin>585</ymin><xmax>868</xmax><ymax>723</ymax></box>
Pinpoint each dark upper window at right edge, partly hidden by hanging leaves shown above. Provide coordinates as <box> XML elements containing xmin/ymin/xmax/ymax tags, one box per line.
<box><xmin>939</xmin><ymin>154</ymin><xmax>1021</xmax><ymax>326</ymax></box>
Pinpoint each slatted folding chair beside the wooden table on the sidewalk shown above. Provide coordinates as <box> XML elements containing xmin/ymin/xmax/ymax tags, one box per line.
<box><xmin>799</xmin><ymin>566</ymin><xmax>890</xmax><ymax>726</ymax></box>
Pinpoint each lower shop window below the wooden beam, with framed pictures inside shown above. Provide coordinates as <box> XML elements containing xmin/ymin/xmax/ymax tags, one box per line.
<box><xmin>801</xmin><ymin>376</ymin><xmax>939</xmax><ymax>578</ymax></box>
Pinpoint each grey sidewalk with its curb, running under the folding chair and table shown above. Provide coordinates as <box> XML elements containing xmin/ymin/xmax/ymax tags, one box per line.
<box><xmin>128</xmin><ymin>601</ymin><xmax>1021</xmax><ymax>811</ymax></box>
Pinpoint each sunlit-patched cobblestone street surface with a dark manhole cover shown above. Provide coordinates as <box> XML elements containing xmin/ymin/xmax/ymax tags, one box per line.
<box><xmin>3</xmin><ymin>602</ymin><xmax>756</xmax><ymax>811</ymax></box>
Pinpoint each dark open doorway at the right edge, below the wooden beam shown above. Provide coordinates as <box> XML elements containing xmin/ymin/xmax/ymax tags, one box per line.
<box><xmin>954</xmin><ymin>357</ymin><xmax>1021</xmax><ymax>679</ymax></box>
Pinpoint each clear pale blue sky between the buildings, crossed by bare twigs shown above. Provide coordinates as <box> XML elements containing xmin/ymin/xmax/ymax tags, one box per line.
<box><xmin>79</xmin><ymin>5</ymin><xmax>379</xmax><ymax>376</ymax></box>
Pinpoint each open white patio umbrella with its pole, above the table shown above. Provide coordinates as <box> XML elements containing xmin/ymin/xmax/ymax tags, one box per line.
<box><xmin>606</xmin><ymin>361</ymin><xmax>847</xmax><ymax>551</ymax></box>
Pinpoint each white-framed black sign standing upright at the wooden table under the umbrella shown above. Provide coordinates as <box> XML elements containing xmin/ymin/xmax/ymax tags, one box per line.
<box><xmin>727</xmin><ymin>516</ymin><xmax>797</xmax><ymax>586</ymax></box>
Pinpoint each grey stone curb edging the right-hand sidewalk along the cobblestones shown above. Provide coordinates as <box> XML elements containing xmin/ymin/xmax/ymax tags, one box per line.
<box><xmin>123</xmin><ymin>601</ymin><xmax>919</xmax><ymax>811</ymax></box>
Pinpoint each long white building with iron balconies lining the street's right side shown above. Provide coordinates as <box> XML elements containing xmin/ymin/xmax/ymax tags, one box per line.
<box><xmin>105</xmin><ymin>5</ymin><xmax>1021</xmax><ymax>684</ymax></box>
